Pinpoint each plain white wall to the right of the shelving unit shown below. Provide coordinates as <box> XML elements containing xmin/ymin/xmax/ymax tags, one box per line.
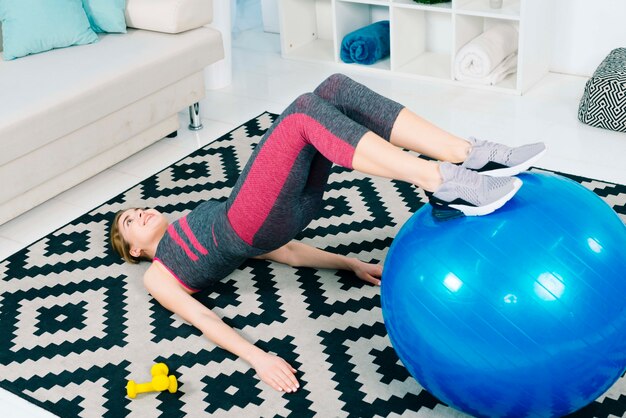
<box><xmin>546</xmin><ymin>0</ymin><xmax>626</xmax><ymax>76</ymax></box>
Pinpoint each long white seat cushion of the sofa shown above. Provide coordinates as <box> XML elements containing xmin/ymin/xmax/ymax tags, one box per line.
<box><xmin>0</xmin><ymin>28</ymin><xmax>224</xmax><ymax>165</ymax></box>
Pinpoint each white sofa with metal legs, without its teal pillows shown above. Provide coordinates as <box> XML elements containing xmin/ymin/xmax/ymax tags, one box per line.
<box><xmin>0</xmin><ymin>0</ymin><xmax>224</xmax><ymax>224</ymax></box>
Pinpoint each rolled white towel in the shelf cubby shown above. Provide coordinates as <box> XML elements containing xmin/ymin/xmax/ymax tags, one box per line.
<box><xmin>454</xmin><ymin>23</ymin><xmax>518</xmax><ymax>84</ymax></box>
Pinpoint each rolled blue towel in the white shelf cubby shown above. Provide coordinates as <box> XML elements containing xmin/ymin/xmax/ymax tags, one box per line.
<box><xmin>340</xmin><ymin>20</ymin><xmax>390</xmax><ymax>65</ymax></box>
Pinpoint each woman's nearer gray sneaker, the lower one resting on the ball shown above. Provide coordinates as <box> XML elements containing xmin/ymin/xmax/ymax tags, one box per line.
<box><xmin>426</xmin><ymin>162</ymin><xmax>522</xmax><ymax>220</ymax></box>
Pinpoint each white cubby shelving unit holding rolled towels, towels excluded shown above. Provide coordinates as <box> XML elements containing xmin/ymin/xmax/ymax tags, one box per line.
<box><xmin>279</xmin><ymin>0</ymin><xmax>552</xmax><ymax>94</ymax></box>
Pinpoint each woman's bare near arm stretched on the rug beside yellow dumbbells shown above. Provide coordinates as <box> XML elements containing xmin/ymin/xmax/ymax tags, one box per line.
<box><xmin>144</xmin><ymin>264</ymin><xmax>299</xmax><ymax>392</ymax></box>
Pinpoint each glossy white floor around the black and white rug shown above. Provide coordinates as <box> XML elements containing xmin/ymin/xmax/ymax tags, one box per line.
<box><xmin>0</xmin><ymin>30</ymin><xmax>626</xmax><ymax>417</ymax></box>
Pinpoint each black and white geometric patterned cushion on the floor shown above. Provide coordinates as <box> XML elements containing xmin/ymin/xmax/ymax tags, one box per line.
<box><xmin>578</xmin><ymin>48</ymin><xmax>626</xmax><ymax>132</ymax></box>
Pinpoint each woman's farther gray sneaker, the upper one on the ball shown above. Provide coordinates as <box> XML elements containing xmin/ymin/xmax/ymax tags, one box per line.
<box><xmin>461</xmin><ymin>137</ymin><xmax>546</xmax><ymax>177</ymax></box>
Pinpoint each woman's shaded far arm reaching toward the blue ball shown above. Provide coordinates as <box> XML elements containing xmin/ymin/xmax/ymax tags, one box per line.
<box><xmin>256</xmin><ymin>241</ymin><xmax>383</xmax><ymax>286</ymax></box>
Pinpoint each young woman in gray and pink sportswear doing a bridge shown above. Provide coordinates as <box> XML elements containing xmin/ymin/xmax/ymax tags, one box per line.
<box><xmin>111</xmin><ymin>74</ymin><xmax>545</xmax><ymax>392</ymax></box>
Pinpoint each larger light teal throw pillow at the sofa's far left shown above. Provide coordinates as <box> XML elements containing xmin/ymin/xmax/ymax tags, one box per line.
<box><xmin>0</xmin><ymin>0</ymin><xmax>98</xmax><ymax>60</ymax></box>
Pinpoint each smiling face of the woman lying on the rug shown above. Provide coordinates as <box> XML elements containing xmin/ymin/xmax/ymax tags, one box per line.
<box><xmin>118</xmin><ymin>208</ymin><xmax>168</xmax><ymax>257</ymax></box>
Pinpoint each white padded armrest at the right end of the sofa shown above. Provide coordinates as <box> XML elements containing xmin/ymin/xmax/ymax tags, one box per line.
<box><xmin>126</xmin><ymin>0</ymin><xmax>212</xmax><ymax>33</ymax></box>
